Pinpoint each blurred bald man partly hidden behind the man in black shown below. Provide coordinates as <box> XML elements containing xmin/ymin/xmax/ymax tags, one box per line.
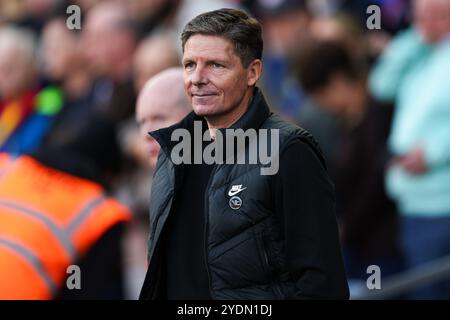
<box><xmin>119</xmin><ymin>68</ymin><xmax>192</xmax><ymax>299</ymax></box>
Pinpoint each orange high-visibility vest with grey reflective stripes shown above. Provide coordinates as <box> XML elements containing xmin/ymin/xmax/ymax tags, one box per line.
<box><xmin>0</xmin><ymin>154</ymin><xmax>131</xmax><ymax>299</ymax></box>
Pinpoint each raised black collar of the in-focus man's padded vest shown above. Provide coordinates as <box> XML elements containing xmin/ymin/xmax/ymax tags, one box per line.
<box><xmin>148</xmin><ymin>87</ymin><xmax>271</xmax><ymax>154</ymax></box>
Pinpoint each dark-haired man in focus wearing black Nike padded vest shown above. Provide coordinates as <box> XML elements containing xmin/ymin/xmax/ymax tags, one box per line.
<box><xmin>140</xmin><ymin>9</ymin><xmax>348</xmax><ymax>299</ymax></box>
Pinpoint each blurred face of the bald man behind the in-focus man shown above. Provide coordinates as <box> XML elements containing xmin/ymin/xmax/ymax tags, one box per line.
<box><xmin>136</xmin><ymin>92</ymin><xmax>188</xmax><ymax>168</ymax></box>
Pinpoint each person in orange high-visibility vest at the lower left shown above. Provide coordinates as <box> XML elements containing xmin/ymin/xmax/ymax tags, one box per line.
<box><xmin>0</xmin><ymin>113</ymin><xmax>131</xmax><ymax>299</ymax></box>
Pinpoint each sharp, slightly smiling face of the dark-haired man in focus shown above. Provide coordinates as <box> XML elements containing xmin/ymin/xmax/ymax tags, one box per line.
<box><xmin>182</xmin><ymin>34</ymin><xmax>259</xmax><ymax>124</ymax></box>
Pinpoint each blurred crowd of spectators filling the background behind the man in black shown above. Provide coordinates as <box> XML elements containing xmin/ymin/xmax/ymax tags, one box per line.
<box><xmin>0</xmin><ymin>0</ymin><xmax>450</xmax><ymax>299</ymax></box>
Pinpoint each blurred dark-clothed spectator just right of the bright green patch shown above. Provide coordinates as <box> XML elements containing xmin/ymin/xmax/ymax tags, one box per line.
<box><xmin>42</xmin><ymin>17</ymin><xmax>95</xmax><ymax>147</ymax></box>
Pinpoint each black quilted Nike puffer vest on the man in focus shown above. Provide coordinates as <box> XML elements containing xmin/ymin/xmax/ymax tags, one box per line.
<box><xmin>140</xmin><ymin>88</ymin><xmax>348</xmax><ymax>299</ymax></box>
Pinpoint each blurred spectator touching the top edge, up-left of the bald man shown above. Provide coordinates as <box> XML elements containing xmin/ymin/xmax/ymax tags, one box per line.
<box><xmin>82</xmin><ymin>1</ymin><xmax>137</xmax><ymax>124</ymax></box>
